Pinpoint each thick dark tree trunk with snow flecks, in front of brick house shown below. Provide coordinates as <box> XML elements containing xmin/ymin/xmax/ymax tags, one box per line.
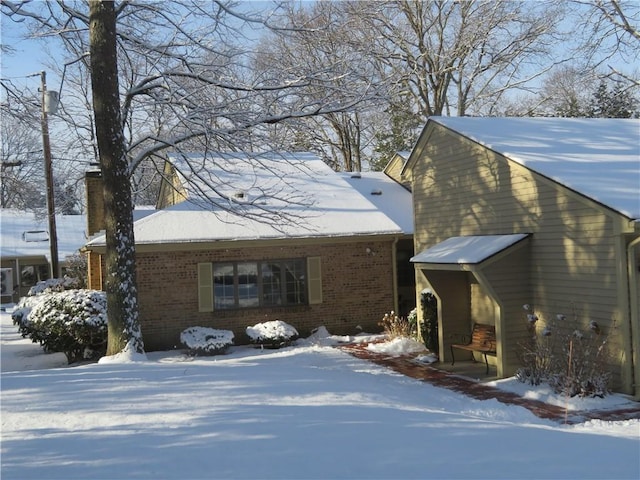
<box><xmin>89</xmin><ymin>0</ymin><xmax>144</xmax><ymax>355</ymax></box>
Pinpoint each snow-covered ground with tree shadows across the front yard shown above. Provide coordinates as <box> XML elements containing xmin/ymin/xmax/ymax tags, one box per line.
<box><xmin>0</xmin><ymin>313</ymin><xmax>640</xmax><ymax>480</ymax></box>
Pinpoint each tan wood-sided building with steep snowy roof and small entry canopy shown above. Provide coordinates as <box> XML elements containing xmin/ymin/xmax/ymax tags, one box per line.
<box><xmin>403</xmin><ymin>117</ymin><xmax>640</xmax><ymax>397</ymax></box>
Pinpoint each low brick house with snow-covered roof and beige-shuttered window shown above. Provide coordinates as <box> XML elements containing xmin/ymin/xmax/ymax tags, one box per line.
<box><xmin>86</xmin><ymin>153</ymin><xmax>415</xmax><ymax>350</ymax></box>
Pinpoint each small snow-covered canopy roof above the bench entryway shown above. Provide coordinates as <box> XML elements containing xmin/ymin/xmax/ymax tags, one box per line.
<box><xmin>411</xmin><ymin>233</ymin><xmax>528</xmax><ymax>265</ymax></box>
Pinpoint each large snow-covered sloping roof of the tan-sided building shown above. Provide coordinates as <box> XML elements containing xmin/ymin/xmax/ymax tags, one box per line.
<box><xmin>429</xmin><ymin>117</ymin><xmax>640</xmax><ymax>219</ymax></box>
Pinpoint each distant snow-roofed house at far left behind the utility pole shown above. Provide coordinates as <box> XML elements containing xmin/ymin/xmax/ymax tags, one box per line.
<box><xmin>0</xmin><ymin>208</ymin><xmax>87</xmax><ymax>303</ymax></box>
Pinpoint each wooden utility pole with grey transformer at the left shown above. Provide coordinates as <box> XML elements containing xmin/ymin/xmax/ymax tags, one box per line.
<box><xmin>40</xmin><ymin>71</ymin><xmax>60</xmax><ymax>278</ymax></box>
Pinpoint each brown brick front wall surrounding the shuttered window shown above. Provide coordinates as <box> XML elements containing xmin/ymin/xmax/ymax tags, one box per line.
<box><xmin>132</xmin><ymin>241</ymin><xmax>394</xmax><ymax>351</ymax></box>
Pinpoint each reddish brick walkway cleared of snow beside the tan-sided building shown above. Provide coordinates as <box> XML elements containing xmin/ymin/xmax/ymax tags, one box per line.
<box><xmin>340</xmin><ymin>344</ymin><xmax>640</xmax><ymax>424</ymax></box>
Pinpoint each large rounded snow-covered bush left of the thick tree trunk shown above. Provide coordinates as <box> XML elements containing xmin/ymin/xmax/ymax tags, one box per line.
<box><xmin>13</xmin><ymin>290</ymin><xmax>107</xmax><ymax>363</ymax></box>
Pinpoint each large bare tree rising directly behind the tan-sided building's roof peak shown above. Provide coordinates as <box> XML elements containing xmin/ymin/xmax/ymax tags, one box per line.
<box><xmin>358</xmin><ymin>0</ymin><xmax>562</xmax><ymax>118</ymax></box>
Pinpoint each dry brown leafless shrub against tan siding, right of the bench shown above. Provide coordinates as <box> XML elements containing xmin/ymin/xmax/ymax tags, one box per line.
<box><xmin>516</xmin><ymin>305</ymin><xmax>610</xmax><ymax>397</ymax></box>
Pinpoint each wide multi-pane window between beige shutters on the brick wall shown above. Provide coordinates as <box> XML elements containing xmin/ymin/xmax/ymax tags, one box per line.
<box><xmin>213</xmin><ymin>259</ymin><xmax>307</xmax><ymax>310</ymax></box>
